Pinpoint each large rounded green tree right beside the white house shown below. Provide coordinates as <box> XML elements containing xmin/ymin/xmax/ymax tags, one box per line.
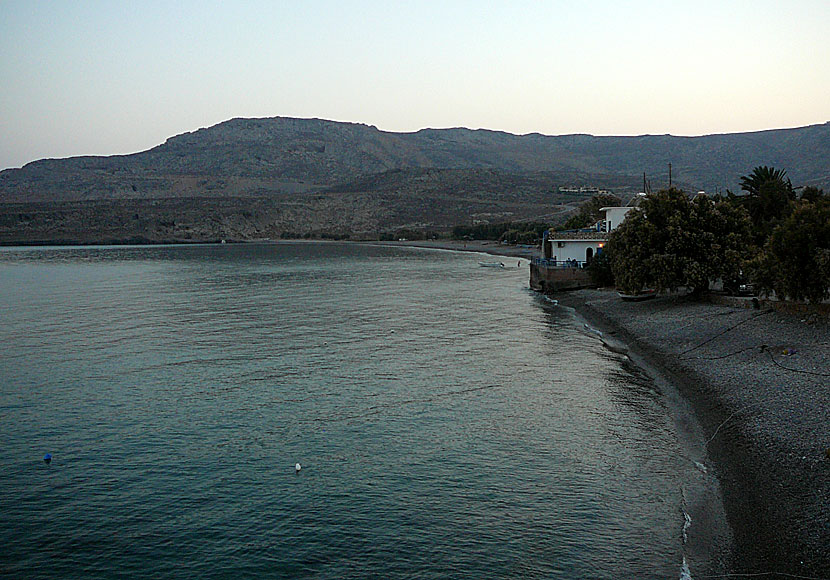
<box><xmin>606</xmin><ymin>188</ymin><xmax>751</xmax><ymax>294</ymax></box>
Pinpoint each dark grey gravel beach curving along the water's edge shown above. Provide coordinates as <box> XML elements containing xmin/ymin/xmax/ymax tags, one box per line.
<box><xmin>557</xmin><ymin>290</ymin><xmax>830</xmax><ymax>578</ymax></box>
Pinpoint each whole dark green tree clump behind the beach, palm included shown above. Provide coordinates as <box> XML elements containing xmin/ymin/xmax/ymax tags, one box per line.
<box><xmin>591</xmin><ymin>166</ymin><xmax>830</xmax><ymax>303</ymax></box>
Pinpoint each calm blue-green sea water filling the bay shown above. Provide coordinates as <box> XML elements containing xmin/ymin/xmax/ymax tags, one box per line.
<box><xmin>0</xmin><ymin>244</ymin><xmax>700</xmax><ymax>578</ymax></box>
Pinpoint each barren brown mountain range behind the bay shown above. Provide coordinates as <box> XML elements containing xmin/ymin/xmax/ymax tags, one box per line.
<box><xmin>0</xmin><ymin>117</ymin><xmax>830</xmax><ymax>243</ymax></box>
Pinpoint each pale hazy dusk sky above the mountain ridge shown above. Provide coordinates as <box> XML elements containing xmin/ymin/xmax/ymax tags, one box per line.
<box><xmin>0</xmin><ymin>0</ymin><xmax>830</xmax><ymax>169</ymax></box>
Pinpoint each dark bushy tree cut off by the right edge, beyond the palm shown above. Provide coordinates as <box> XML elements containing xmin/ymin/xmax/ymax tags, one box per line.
<box><xmin>752</xmin><ymin>198</ymin><xmax>830</xmax><ymax>303</ymax></box>
